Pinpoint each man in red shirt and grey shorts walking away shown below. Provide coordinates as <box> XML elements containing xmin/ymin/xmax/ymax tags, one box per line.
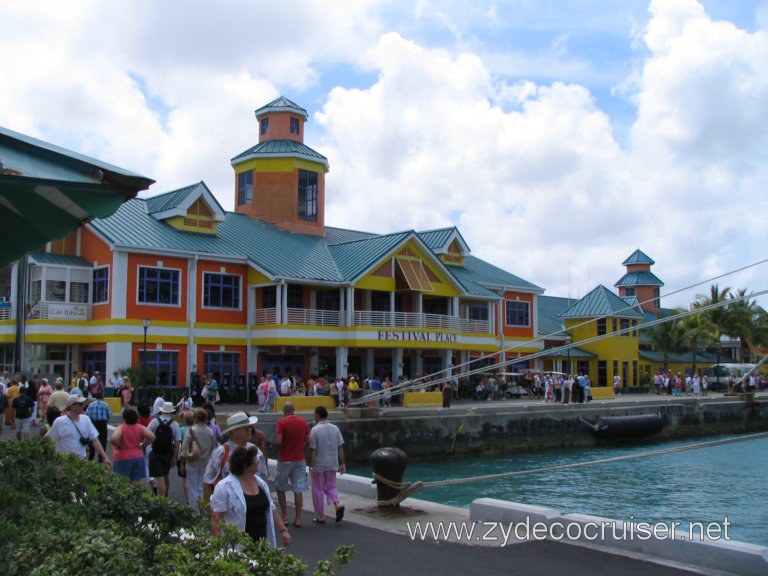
<box><xmin>275</xmin><ymin>402</ymin><xmax>309</xmax><ymax>528</ymax></box>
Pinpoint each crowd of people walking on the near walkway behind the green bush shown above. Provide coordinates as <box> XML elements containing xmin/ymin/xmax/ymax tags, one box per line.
<box><xmin>0</xmin><ymin>373</ymin><xmax>346</xmax><ymax>547</ymax></box>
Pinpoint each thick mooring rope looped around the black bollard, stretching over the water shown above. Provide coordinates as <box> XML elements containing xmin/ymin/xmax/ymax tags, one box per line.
<box><xmin>373</xmin><ymin>432</ymin><xmax>768</xmax><ymax>500</ymax></box>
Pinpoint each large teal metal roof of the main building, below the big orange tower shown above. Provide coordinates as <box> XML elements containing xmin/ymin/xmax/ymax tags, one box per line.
<box><xmin>89</xmin><ymin>190</ymin><xmax>541</xmax><ymax>299</ymax></box>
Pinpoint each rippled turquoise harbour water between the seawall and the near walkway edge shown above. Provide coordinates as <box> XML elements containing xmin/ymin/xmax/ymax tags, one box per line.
<box><xmin>349</xmin><ymin>436</ymin><xmax>768</xmax><ymax>545</ymax></box>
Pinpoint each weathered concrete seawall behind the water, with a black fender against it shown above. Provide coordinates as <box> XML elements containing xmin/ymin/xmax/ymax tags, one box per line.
<box><xmin>250</xmin><ymin>396</ymin><xmax>768</xmax><ymax>462</ymax></box>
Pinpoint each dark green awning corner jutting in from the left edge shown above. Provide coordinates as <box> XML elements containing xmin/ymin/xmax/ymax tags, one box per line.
<box><xmin>0</xmin><ymin>128</ymin><xmax>154</xmax><ymax>266</ymax></box>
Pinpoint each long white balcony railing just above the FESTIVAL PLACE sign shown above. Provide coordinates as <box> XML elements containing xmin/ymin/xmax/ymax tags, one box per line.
<box><xmin>254</xmin><ymin>308</ymin><xmax>490</xmax><ymax>334</ymax></box>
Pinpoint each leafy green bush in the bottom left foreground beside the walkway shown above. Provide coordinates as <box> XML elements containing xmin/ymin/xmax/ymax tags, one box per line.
<box><xmin>0</xmin><ymin>438</ymin><xmax>353</xmax><ymax>576</ymax></box>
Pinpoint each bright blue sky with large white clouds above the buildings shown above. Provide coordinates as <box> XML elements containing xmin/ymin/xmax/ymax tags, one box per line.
<box><xmin>0</xmin><ymin>0</ymin><xmax>768</xmax><ymax>307</ymax></box>
